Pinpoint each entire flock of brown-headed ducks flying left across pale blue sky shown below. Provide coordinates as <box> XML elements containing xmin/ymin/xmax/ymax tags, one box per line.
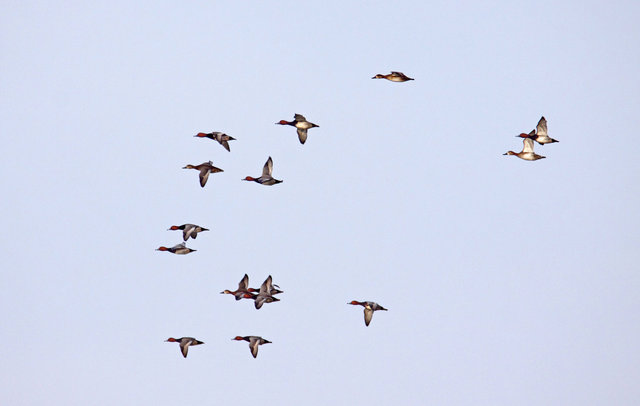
<box><xmin>157</xmin><ymin>71</ymin><xmax>558</xmax><ymax>358</ymax></box>
